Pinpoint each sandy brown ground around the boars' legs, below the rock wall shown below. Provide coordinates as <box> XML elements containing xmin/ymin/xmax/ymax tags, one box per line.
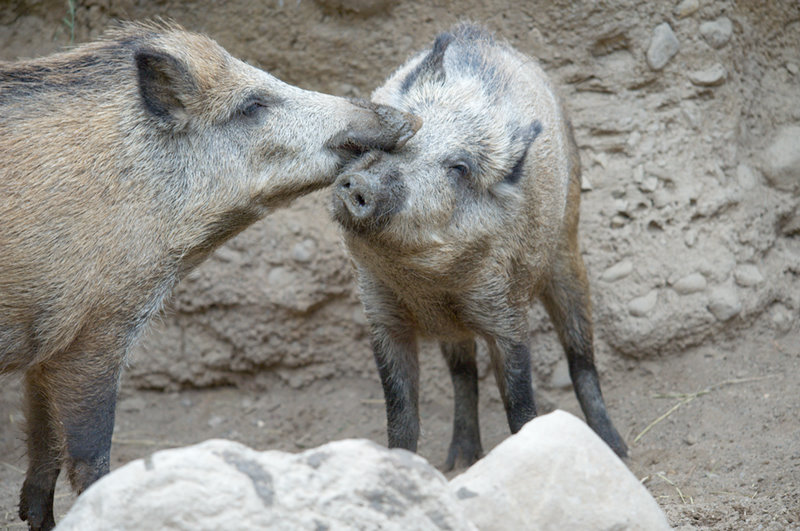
<box><xmin>0</xmin><ymin>326</ymin><xmax>800</xmax><ymax>530</ymax></box>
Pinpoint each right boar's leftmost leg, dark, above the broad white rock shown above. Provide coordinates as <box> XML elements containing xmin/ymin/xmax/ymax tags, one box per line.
<box><xmin>372</xmin><ymin>326</ymin><xmax>419</xmax><ymax>452</ymax></box>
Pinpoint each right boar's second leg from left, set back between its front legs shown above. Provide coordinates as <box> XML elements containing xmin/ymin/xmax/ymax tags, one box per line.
<box><xmin>440</xmin><ymin>339</ymin><xmax>483</xmax><ymax>470</ymax></box>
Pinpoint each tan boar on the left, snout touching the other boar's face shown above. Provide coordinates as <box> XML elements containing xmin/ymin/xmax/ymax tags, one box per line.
<box><xmin>0</xmin><ymin>23</ymin><xmax>419</xmax><ymax>529</ymax></box>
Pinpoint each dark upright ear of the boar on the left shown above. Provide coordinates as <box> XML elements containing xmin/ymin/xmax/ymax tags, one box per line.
<box><xmin>134</xmin><ymin>48</ymin><xmax>195</xmax><ymax>125</ymax></box>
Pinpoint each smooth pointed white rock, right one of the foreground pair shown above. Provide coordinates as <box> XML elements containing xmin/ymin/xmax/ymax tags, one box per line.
<box><xmin>450</xmin><ymin>411</ymin><xmax>670</xmax><ymax>531</ymax></box>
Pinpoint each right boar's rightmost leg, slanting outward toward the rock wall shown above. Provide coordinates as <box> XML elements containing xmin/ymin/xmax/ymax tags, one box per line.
<box><xmin>542</xmin><ymin>250</ymin><xmax>628</xmax><ymax>457</ymax></box>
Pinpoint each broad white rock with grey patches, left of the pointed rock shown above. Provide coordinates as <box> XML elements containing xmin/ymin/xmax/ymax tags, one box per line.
<box><xmin>58</xmin><ymin>440</ymin><xmax>475</xmax><ymax>531</ymax></box>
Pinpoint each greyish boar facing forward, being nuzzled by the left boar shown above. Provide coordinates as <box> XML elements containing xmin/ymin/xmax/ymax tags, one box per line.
<box><xmin>332</xmin><ymin>24</ymin><xmax>627</xmax><ymax>469</ymax></box>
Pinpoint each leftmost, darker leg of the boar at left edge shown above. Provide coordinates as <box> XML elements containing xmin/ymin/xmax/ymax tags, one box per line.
<box><xmin>19</xmin><ymin>367</ymin><xmax>61</xmax><ymax>530</ymax></box>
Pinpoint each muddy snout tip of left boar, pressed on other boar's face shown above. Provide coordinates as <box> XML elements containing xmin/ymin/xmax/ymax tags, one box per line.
<box><xmin>328</xmin><ymin>101</ymin><xmax>422</xmax><ymax>158</ymax></box>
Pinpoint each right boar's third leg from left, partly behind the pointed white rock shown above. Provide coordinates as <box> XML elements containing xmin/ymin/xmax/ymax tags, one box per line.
<box><xmin>488</xmin><ymin>339</ymin><xmax>536</xmax><ymax>433</ymax></box>
